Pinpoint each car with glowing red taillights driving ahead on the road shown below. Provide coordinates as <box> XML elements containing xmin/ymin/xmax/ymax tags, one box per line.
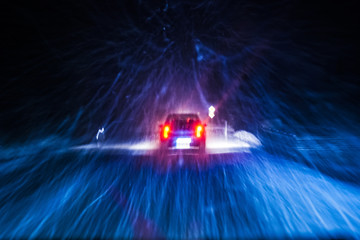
<box><xmin>160</xmin><ymin>113</ymin><xmax>206</xmax><ymax>153</ymax></box>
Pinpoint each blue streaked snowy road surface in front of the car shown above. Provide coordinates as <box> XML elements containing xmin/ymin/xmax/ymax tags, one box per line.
<box><xmin>0</xmin><ymin>137</ymin><xmax>360</xmax><ymax>238</ymax></box>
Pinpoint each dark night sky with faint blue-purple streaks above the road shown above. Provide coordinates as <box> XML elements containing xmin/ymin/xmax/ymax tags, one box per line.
<box><xmin>0</xmin><ymin>0</ymin><xmax>360</xmax><ymax>142</ymax></box>
